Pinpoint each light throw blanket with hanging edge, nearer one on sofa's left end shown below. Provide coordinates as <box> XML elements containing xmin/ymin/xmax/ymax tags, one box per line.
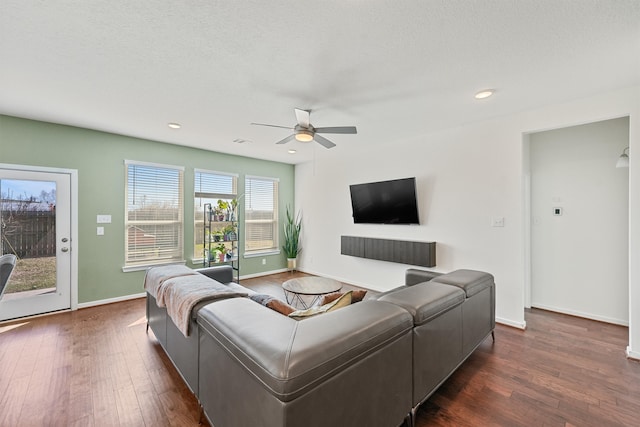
<box><xmin>156</xmin><ymin>274</ymin><xmax>247</xmax><ymax>337</ymax></box>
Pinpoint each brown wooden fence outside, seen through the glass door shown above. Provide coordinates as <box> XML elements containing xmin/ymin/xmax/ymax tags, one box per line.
<box><xmin>0</xmin><ymin>211</ymin><xmax>56</xmax><ymax>258</ymax></box>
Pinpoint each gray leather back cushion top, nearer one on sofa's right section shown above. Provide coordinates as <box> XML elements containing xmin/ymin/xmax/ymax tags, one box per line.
<box><xmin>378</xmin><ymin>282</ymin><xmax>464</xmax><ymax>325</ymax></box>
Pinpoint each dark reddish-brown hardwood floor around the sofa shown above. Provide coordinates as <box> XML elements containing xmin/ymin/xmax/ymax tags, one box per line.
<box><xmin>0</xmin><ymin>273</ymin><xmax>640</xmax><ymax>427</ymax></box>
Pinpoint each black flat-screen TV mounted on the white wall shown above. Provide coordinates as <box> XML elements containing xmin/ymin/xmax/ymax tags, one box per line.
<box><xmin>349</xmin><ymin>178</ymin><xmax>420</xmax><ymax>224</ymax></box>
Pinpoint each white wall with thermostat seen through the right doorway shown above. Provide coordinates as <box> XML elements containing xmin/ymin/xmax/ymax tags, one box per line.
<box><xmin>530</xmin><ymin>117</ymin><xmax>629</xmax><ymax>325</ymax></box>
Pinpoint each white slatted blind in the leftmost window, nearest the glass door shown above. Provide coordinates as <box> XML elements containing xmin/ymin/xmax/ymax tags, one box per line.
<box><xmin>125</xmin><ymin>161</ymin><xmax>184</xmax><ymax>267</ymax></box>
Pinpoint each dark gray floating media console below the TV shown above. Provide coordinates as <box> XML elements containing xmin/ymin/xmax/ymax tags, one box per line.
<box><xmin>340</xmin><ymin>236</ymin><xmax>436</xmax><ymax>267</ymax></box>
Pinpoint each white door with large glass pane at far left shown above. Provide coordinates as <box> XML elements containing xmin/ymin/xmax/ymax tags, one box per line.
<box><xmin>0</xmin><ymin>165</ymin><xmax>73</xmax><ymax>320</ymax></box>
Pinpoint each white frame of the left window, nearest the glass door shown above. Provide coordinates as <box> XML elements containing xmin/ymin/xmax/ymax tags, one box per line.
<box><xmin>122</xmin><ymin>160</ymin><xmax>186</xmax><ymax>272</ymax></box>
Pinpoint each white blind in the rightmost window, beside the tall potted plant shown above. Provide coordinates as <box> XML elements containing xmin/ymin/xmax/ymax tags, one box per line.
<box><xmin>244</xmin><ymin>176</ymin><xmax>278</xmax><ymax>254</ymax></box>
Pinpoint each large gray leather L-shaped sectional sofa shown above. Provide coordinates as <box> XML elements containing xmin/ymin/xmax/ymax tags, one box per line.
<box><xmin>147</xmin><ymin>267</ymin><xmax>495</xmax><ymax>427</ymax></box>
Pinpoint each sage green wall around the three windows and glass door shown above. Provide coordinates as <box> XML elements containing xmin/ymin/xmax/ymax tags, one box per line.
<box><xmin>0</xmin><ymin>115</ymin><xmax>294</xmax><ymax>303</ymax></box>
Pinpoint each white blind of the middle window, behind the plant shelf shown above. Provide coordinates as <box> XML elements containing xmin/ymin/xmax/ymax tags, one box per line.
<box><xmin>193</xmin><ymin>169</ymin><xmax>238</xmax><ymax>258</ymax></box>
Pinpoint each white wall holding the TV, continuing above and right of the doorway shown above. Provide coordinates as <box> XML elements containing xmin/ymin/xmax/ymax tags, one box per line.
<box><xmin>296</xmin><ymin>87</ymin><xmax>640</xmax><ymax>358</ymax></box>
